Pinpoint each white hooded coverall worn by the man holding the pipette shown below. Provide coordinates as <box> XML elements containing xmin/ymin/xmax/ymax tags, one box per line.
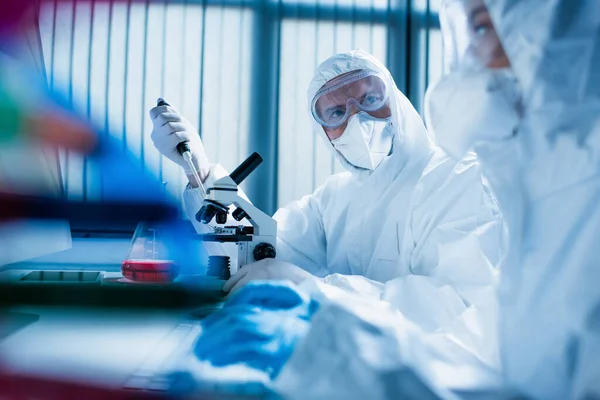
<box><xmin>184</xmin><ymin>50</ymin><xmax>503</xmax><ymax>346</ymax></box>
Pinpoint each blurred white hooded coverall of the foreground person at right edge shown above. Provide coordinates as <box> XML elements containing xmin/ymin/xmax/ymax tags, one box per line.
<box><xmin>476</xmin><ymin>0</ymin><xmax>600</xmax><ymax>399</ymax></box>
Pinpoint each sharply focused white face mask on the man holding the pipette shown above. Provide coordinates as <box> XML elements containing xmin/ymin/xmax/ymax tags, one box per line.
<box><xmin>331</xmin><ymin>111</ymin><xmax>394</xmax><ymax>170</ymax></box>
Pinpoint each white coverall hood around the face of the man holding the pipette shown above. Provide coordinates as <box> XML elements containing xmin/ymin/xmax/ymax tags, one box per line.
<box><xmin>307</xmin><ymin>49</ymin><xmax>434</xmax><ymax>177</ymax></box>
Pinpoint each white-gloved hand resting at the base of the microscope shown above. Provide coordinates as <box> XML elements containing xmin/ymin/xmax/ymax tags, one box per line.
<box><xmin>223</xmin><ymin>258</ymin><xmax>318</xmax><ymax>292</ymax></box>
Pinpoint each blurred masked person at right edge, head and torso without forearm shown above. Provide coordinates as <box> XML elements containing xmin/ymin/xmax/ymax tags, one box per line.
<box><xmin>429</xmin><ymin>0</ymin><xmax>600</xmax><ymax>399</ymax></box>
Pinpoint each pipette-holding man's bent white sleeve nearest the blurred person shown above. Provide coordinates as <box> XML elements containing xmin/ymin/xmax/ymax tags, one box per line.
<box><xmin>382</xmin><ymin>155</ymin><xmax>504</xmax><ymax>366</ymax></box>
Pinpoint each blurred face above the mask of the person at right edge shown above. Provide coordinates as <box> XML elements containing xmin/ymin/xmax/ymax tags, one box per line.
<box><xmin>450</xmin><ymin>0</ymin><xmax>510</xmax><ymax>69</ymax></box>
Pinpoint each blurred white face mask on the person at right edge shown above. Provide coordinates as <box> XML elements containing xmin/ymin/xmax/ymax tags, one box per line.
<box><xmin>425</xmin><ymin>69</ymin><xmax>521</xmax><ymax>159</ymax></box>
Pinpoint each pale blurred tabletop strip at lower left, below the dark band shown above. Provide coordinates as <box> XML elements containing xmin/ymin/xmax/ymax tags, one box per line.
<box><xmin>0</xmin><ymin>306</ymin><xmax>195</xmax><ymax>388</ymax></box>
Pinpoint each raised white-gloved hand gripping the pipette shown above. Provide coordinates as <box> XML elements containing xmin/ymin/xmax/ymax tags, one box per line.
<box><xmin>150</xmin><ymin>106</ymin><xmax>210</xmax><ymax>181</ymax></box>
